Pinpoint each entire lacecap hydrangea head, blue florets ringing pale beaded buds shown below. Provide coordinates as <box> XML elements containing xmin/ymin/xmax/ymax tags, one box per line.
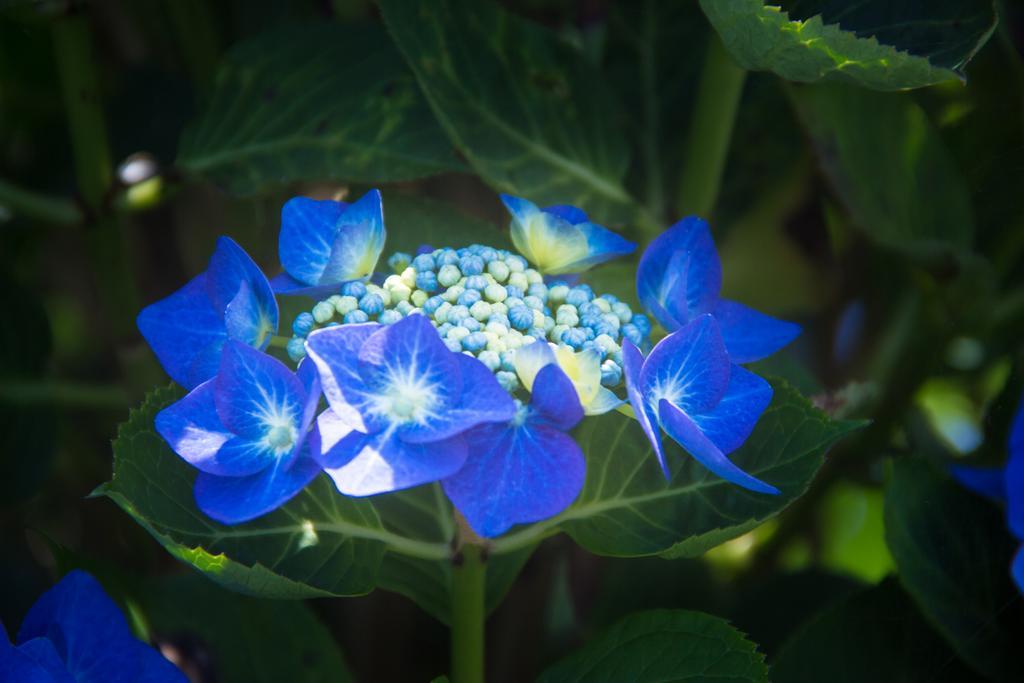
<box><xmin>138</xmin><ymin>190</ymin><xmax>799</xmax><ymax>537</ymax></box>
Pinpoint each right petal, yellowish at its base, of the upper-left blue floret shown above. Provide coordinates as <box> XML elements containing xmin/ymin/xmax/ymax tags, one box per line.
<box><xmin>318</xmin><ymin>189</ymin><xmax>386</xmax><ymax>285</ymax></box>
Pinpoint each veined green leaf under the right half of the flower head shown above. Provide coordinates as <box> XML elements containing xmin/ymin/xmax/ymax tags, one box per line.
<box><xmin>494</xmin><ymin>380</ymin><xmax>863</xmax><ymax>557</ymax></box>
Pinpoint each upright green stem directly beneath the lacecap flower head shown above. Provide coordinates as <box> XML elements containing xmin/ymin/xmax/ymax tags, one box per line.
<box><xmin>452</xmin><ymin>544</ymin><xmax>486</xmax><ymax>683</ymax></box>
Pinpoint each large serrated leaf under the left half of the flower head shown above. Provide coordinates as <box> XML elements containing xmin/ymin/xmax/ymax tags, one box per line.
<box><xmin>97</xmin><ymin>388</ymin><xmax>535</xmax><ymax>622</ymax></box>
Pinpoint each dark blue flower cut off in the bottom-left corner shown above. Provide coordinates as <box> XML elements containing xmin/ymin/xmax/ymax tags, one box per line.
<box><xmin>0</xmin><ymin>569</ymin><xmax>188</xmax><ymax>683</ymax></box>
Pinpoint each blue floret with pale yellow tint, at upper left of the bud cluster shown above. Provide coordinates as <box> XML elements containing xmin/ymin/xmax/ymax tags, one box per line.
<box><xmin>272</xmin><ymin>189</ymin><xmax>386</xmax><ymax>296</ymax></box>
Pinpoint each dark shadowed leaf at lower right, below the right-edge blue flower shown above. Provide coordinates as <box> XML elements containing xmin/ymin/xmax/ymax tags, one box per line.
<box><xmin>885</xmin><ymin>460</ymin><xmax>1024</xmax><ymax>680</ymax></box>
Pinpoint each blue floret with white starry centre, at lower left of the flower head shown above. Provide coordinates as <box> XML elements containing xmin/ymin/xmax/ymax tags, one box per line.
<box><xmin>156</xmin><ymin>342</ymin><xmax>321</xmax><ymax>524</ymax></box>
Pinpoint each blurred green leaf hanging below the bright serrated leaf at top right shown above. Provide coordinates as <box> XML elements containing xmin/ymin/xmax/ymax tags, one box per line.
<box><xmin>793</xmin><ymin>86</ymin><xmax>975</xmax><ymax>254</ymax></box>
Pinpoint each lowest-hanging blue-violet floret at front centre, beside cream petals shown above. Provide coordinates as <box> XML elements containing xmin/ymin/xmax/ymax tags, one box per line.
<box><xmin>442</xmin><ymin>341</ymin><xmax>586</xmax><ymax>538</ymax></box>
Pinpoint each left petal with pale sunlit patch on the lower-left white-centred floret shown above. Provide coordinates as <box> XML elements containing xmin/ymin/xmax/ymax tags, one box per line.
<box><xmin>156</xmin><ymin>380</ymin><xmax>273</xmax><ymax>476</ymax></box>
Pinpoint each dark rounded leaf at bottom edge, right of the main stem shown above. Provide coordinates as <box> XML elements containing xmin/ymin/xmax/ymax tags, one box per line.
<box><xmin>537</xmin><ymin>609</ymin><xmax>768</xmax><ymax>683</ymax></box>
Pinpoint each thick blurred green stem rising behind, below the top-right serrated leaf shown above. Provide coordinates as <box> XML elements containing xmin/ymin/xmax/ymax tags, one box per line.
<box><xmin>676</xmin><ymin>32</ymin><xmax>746</xmax><ymax>216</ymax></box>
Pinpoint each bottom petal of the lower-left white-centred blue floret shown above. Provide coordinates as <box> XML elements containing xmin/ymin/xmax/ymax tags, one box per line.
<box><xmin>195</xmin><ymin>446</ymin><xmax>321</xmax><ymax>524</ymax></box>
